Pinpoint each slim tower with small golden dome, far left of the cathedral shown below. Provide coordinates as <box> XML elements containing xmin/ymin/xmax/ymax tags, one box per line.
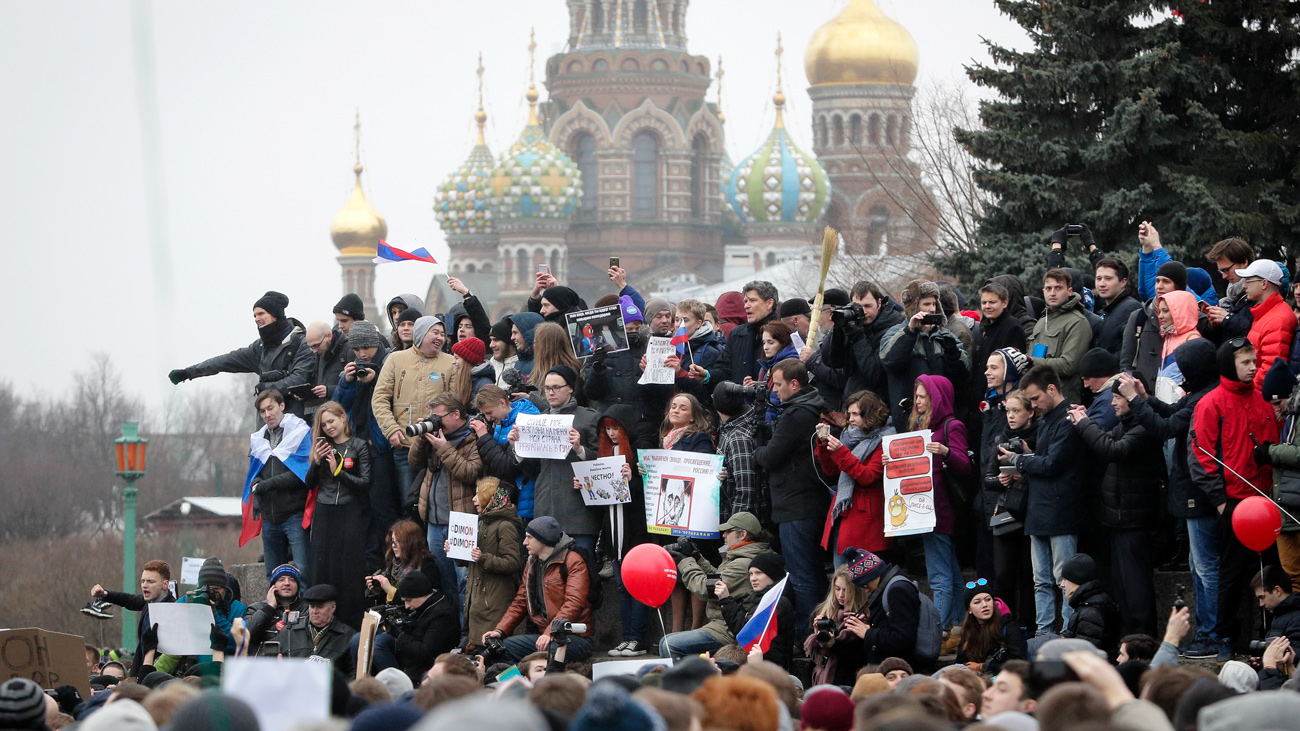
<box><xmin>329</xmin><ymin>112</ymin><xmax>389</xmax><ymax>328</ymax></box>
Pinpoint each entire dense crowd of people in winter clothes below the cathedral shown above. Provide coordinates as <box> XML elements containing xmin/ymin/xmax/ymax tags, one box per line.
<box><xmin>32</xmin><ymin>222</ymin><xmax>1300</xmax><ymax>731</ymax></box>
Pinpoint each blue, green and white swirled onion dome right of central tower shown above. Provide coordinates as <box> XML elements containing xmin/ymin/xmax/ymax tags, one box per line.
<box><xmin>725</xmin><ymin>92</ymin><xmax>831</xmax><ymax>224</ymax></box>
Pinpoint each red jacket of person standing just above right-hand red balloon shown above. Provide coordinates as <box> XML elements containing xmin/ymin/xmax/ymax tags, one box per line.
<box><xmin>1190</xmin><ymin>376</ymin><xmax>1278</xmax><ymax>506</ymax></box>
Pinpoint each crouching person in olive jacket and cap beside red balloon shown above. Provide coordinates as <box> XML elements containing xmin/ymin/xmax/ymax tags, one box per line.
<box><xmin>659</xmin><ymin>512</ymin><xmax>772</xmax><ymax>659</ymax></box>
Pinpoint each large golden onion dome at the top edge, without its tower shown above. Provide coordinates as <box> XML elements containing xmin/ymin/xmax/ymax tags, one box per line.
<box><xmin>803</xmin><ymin>0</ymin><xmax>920</xmax><ymax>86</ymax></box>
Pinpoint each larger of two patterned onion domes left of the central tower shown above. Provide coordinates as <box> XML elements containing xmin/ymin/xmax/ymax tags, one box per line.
<box><xmin>488</xmin><ymin>88</ymin><xmax>582</xmax><ymax>221</ymax></box>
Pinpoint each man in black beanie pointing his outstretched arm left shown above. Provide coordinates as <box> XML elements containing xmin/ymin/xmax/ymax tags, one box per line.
<box><xmin>168</xmin><ymin>291</ymin><xmax>316</xmax><ymax>416</ymax></box>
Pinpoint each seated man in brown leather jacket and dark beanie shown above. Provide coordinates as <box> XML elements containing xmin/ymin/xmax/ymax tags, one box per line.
<box><xmin>478</xmin><ymin>515</ymin><xmax>592</xmax><ymax>662</ymax></box>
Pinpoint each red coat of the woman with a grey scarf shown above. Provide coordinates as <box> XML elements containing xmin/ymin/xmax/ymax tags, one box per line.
<box><xmin>816</xmin><ymin>442</ymin><xmax>893</xmax><ymax>554</ymax></box>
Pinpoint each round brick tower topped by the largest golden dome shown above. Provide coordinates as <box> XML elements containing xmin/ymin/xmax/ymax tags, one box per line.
<box><xmin>805</xmin><ymin>0</ymin><xmax>935</xmax><ymax>255</ymax></box>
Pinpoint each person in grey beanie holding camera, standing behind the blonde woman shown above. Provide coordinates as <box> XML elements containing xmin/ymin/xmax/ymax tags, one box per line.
<box><xmin>334</xmin><ymin>320</ymin><xmax>406</xmax><ymax>568</ymax></box>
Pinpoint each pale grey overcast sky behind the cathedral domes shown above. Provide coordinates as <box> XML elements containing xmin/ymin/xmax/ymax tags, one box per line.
<box><xmin>0</xmin><ymin>0</ymin><xmax>1024</xmax><ymax>405</ymax></box>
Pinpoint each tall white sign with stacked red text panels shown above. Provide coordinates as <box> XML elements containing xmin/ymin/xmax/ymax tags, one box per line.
<box><xmin>880</xmin><ymin>429</ymin><xmax>936</xmax><ymax>537</ymax></box>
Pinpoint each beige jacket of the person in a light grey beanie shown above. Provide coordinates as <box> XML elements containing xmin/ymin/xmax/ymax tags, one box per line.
<box><xmin>371</xmin><ymin>347</ymin><xmax>456</xmax><ymax>447</ymax></box>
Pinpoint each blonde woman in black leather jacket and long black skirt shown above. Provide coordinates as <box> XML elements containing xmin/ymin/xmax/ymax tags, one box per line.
<box><xmin>304</xmin><ymin>401</ymin><xmax>371</xmax><ymax>627</ymax></box>
